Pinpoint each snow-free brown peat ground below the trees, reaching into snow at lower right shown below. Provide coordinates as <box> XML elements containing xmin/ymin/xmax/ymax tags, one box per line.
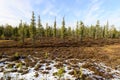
<box><xmin>0</xmin><ymin>38</ymin><xmax>120</xmax><ymax>80</ymax></box>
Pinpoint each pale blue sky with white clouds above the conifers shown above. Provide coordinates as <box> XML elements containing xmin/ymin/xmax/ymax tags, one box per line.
<box><xmin>0</xmin><ymin>0</ymin><xmax>120</xmax><ymax>29</ymax></box>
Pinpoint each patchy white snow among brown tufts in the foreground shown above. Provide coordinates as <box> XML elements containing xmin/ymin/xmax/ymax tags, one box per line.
<box><xmin>0</xmin><ymin>56</ymin><xmax>120</xmax><ymax>80</ymax></box>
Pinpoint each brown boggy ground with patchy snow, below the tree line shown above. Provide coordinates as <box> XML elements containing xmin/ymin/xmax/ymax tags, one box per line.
<box><xmin>0</xmin><ymin>38</ymin><xmax>120</xmax><ymax>80</ymax></box>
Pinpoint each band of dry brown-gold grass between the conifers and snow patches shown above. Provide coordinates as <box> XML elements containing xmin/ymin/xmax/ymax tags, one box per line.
<box><xmin>0</xmin><ymin>39</ymin><xmax>120</xmax><ymax>67</ymax></box>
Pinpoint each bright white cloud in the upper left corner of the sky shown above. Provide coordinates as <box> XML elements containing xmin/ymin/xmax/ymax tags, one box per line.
<box><xmin>0</xmin><ymin>0</ymin><xmax>33</xmax><ymax>25</ymax></box>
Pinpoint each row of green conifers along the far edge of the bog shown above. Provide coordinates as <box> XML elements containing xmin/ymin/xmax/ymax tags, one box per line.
<box><xmin>0</xmin><ymin>12</ymin><xmax>120</xmax><ymax>44</ymax></box>
